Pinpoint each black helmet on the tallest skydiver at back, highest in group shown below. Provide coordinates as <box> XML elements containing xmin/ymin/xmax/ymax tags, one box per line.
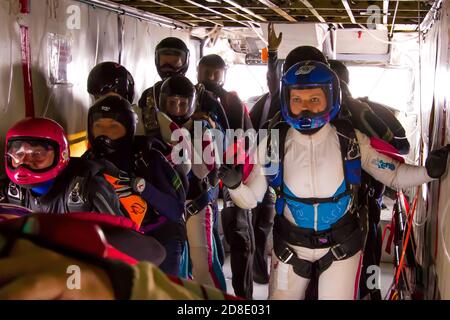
<box><xmin>155</xmin><ymin>37</ymin><xmax>189</xmax><ymax>80</ymax></box>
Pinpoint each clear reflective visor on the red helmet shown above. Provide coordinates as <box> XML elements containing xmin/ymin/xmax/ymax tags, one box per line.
<box><xmin>6</xmin><ymin>138</ymin><xmax>58</xmax><ymax>172</ymax></box>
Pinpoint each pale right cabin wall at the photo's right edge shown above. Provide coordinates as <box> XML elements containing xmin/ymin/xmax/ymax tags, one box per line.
<box><xmin>414</xmin><ymin>1</ymin><xmax>450</xmax><ymax>299</ymax></box>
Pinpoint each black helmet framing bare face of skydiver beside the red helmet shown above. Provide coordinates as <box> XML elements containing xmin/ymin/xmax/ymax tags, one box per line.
<box><xmin>88</xmin><ymin>95</ymin><xmax>137</xmax><ymax>155</ymax></box>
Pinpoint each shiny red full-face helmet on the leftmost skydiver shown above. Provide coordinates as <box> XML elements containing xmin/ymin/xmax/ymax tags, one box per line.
<box><xmin>5</xmin><ymin>118</ymin><xmax>70</xmax><ymax>186</ymax></box>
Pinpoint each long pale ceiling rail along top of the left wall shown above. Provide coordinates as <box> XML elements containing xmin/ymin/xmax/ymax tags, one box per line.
<box><xmin>75</xmin><ymin>0</ymin><xmax>190</xmax><ymax>29</ymax></box>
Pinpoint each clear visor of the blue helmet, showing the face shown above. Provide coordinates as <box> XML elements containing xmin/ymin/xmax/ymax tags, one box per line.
<box><xmin>285</xmin><ymin>85</ymin><xmax>333</xmax><ymax>119</ymax></box>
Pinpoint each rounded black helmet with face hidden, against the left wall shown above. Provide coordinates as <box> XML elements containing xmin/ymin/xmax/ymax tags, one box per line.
<box><xmin>87</xmin><ymin>61</ymin><xmax>134</xmax><ymax>103</ymax></box>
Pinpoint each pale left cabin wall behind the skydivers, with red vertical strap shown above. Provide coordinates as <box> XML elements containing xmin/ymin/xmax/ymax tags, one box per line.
<box><xmin>0</xmin><ymin>0</ymin><xmax>192</xmax><ymax>168</ymax></box>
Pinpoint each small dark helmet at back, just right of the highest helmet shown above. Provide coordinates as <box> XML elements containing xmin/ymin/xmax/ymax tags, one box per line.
<box><xmin>197</xmin><ymin>54</ymin><xmax>227</xmax><ymax>87</ymax></box>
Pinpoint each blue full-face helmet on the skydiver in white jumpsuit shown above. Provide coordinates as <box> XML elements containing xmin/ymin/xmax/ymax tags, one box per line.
<box><xmin>281</xmin><ymin>61</ymin><xmax>341</xmax><ymax>131</ymax></box>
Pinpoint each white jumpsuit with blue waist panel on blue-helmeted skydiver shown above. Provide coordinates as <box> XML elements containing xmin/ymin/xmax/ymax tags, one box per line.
<box><xmin>230</xmin><ymin>124</ymin><xmax>432</xmax><ymax>299</ymax></box>
